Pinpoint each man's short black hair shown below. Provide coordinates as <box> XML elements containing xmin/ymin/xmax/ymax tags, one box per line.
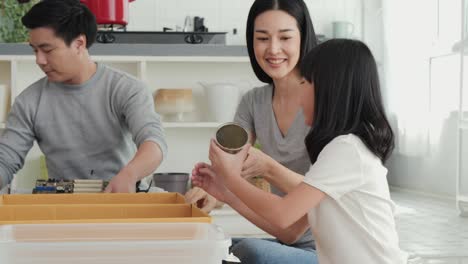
<box><xmin>21</xmin><ymin>0</ymin><xmax>97</xmax><ymax>48</ymax></box>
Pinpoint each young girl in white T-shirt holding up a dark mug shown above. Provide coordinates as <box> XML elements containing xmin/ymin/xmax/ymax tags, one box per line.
<box><xmin>192</xmin><ymin>39</ymin><xmax>407</xmax><ymax>264</ymax></box>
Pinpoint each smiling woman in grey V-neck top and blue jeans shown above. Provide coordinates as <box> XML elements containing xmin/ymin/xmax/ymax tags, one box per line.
<box><xmin>186</xmin><ymin>0</ymin><xmax>316</xmax><ymax>263</ymax></box>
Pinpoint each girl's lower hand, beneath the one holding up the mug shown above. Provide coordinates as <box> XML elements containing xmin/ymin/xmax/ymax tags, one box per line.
<box><xmin>192</xmin><ymin>162</ymin><xmax>233</xmax><ymax>203</ymax></box>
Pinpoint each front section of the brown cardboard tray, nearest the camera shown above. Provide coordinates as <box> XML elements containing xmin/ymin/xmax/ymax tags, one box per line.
<box><xmin>0</xmin><ymin>204</ymin><xmax>211</xmax><ymax>225</ymax></box>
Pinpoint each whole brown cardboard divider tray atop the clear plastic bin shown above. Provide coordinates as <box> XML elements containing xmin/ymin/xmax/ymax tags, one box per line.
<box><xmin>0</xmin><ymin>193</ymin><xmax>211</xmax><ymax>225</ymax></box>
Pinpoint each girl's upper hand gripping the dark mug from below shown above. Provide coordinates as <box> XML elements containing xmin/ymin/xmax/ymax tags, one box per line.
<box><xmin>209</xmin><ymin>139</ymin><xmax>250</xmax><ymax>184</ymax></box>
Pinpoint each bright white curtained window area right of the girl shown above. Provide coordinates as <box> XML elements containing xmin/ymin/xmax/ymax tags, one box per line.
<box><xmin>383</xmin><ymin>0</ymin><xmax>461</xmax><ymax>197</ymax></box>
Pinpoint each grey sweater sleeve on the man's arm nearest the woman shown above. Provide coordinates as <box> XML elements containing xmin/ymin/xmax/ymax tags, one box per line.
<box><xmin>119</xmin><ymin>78</ymin><xmax>167</xmax><ymax>159</ymax></box>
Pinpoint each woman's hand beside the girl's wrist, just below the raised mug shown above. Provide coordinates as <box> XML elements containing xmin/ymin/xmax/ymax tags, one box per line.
<box><xmin>241</xmin><ymin>148</ymin><xmax>271</xmax><ymax>179</ymax></box>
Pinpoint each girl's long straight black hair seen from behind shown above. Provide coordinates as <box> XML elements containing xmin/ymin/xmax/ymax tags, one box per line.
<box><xmin>301</xmin><ymin>39</ymin><xmax>394</xmax><ymax>163</ymax></box>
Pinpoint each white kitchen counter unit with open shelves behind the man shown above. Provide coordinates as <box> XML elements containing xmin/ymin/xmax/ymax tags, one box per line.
<box><xmin>0</xmin><ymin>44</ymin><xmax>262</xmax><ymax>190</ymax></box>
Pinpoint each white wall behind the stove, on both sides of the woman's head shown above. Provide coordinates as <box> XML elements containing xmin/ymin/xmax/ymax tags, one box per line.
<box><xmin>127</xmin><ymin>0</ymin><xmax>364</xmax><ymax>45</ymax></box>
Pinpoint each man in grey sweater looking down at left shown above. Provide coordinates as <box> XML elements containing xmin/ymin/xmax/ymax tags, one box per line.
<box><xmin>0</xmin><ymin>0</ymin><xmax>167</xmax><ymax>192</ymax></box>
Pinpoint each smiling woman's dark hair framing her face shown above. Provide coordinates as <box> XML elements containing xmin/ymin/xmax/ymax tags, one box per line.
<box><xmin>246</xmin><ymin>0</ymin><xmax>317</xmax><ymax>84</ymax></box>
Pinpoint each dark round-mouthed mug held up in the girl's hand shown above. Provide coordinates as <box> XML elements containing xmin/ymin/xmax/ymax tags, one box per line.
<box><xmin>215</xmin><ymin>122</ymin><xmax>249</xmax><ymax>154</ymax></box>
